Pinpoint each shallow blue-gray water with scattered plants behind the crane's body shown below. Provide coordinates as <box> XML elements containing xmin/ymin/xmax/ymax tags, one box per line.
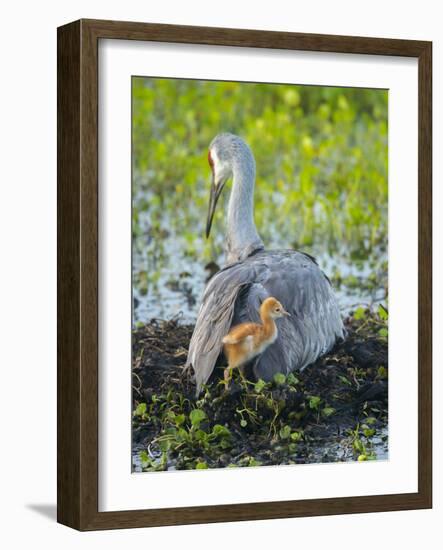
<box><xmin>132</xmin><ymin>178</ymin><xmax>387</xmax><ymax>324</ymax></box>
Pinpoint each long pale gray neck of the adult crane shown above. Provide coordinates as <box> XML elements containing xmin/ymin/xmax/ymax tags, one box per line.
<box><xmin>227</xmin><ymin>158</ymin><xmax>264</xmax><ymax>263</ymax></box>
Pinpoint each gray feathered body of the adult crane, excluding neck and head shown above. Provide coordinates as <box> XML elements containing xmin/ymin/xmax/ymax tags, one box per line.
<box><xmin>187</xmin><ymin>251</ymin><xmax>344</xmax><ymax>395</ymax></box>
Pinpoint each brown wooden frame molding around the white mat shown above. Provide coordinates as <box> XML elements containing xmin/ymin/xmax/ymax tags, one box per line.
<box><xmin>57</xmin><ymin>20</ymin><xmax>432</xmax><ymax>530</ymax></box>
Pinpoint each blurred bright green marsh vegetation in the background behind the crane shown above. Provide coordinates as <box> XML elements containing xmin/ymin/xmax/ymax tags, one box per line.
<box><xmin>132</xmin><ymin>77</ymin><xmax>388</xmax><ymax>324</ymax></box>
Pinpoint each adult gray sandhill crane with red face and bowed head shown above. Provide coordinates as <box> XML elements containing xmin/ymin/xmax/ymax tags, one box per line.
<box><xmin>187</xmin><ymin>133</ymin><xmax>345</xmax><ymax>396</ymax></box>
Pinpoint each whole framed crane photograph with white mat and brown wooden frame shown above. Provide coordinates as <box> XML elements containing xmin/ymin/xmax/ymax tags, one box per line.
<box><xmin>58</xmin><ymin>20</ymin><xmax>432</xmax><ymax>530</ymax></box>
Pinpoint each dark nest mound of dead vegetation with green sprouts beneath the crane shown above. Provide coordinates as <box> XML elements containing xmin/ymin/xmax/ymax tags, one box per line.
<box><xmin>132</xmin><ymin>308</ymin><xmax>388</xmax><ymax>470</ymax></box>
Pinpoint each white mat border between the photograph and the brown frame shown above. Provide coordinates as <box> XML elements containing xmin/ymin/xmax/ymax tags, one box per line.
<box><xmin>99</xmin><ymin>40</ymin><xmax>418</xmax><ymax>511</ymax></box>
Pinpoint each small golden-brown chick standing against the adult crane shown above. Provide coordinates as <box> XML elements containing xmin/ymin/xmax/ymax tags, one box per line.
<box><xmin>223</xmin><ymin>297</ymin><xmax>289</xmax><ymax>388</ymax></box>
